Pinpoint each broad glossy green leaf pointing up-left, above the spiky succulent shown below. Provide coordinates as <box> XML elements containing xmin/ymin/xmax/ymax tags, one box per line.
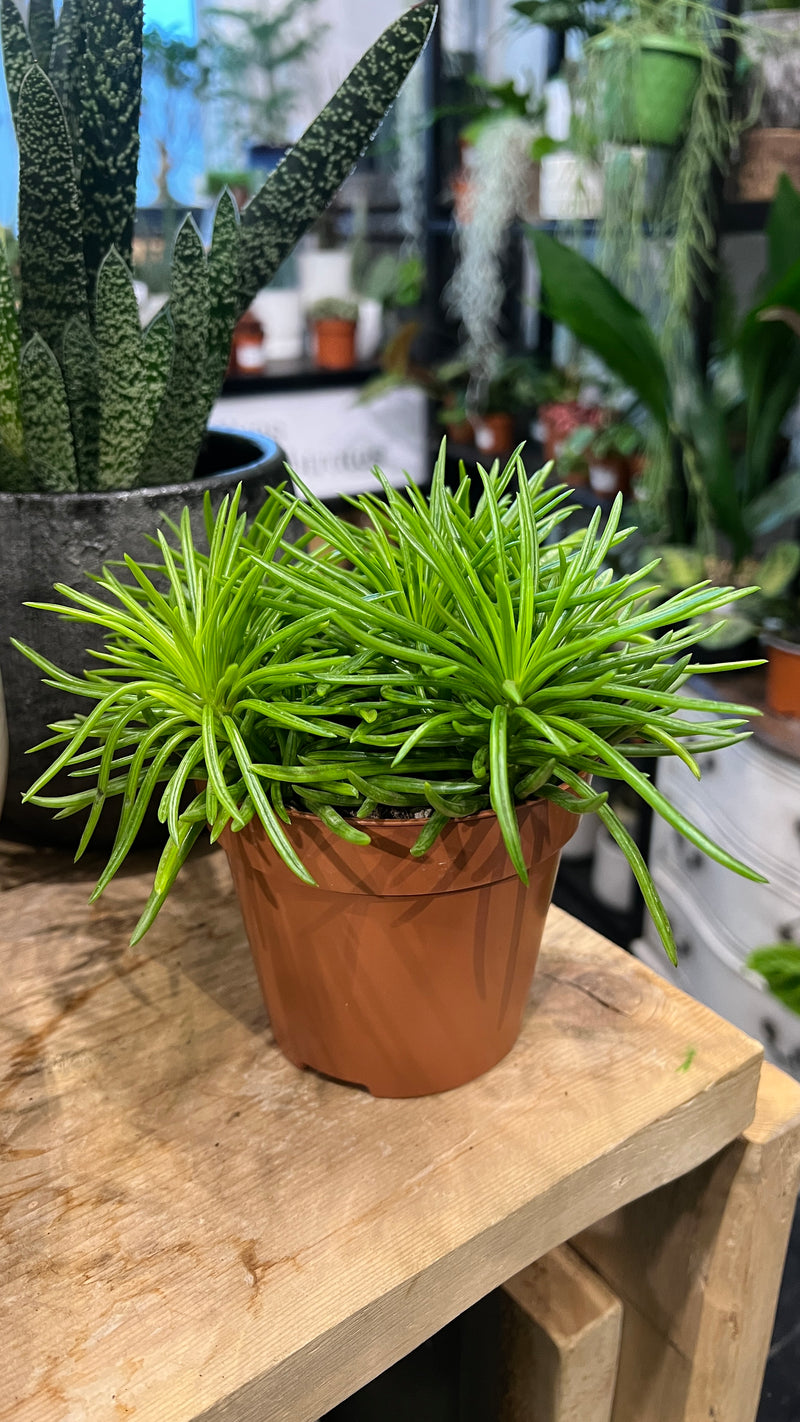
<box><xmin>533</xmin><ymin>232</ymin><xmax>671</xmax><ymax>431</ymax></box>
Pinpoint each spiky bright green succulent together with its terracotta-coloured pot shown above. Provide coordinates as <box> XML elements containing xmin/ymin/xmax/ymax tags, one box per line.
<box><xmin>20</xmin><ymin>448</ymin><xmax>759</xmax><ymax>1095</ymax></box>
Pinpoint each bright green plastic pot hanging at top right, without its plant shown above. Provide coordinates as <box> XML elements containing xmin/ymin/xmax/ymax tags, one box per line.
<box><xmin>602</xmin><ymin>34</ymin><xmax>702</xmax><ymax>148</ymax></box>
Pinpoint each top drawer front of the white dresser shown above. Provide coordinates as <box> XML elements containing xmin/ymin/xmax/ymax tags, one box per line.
<box><xmin>656</xmin><ymin>741</ymin><xmax>800</xmax><ymax>881</ymax></box>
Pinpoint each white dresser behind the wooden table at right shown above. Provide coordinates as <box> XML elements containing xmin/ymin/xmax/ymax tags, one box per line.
<box><xmin>632</xmin><ymin>674</ymin><xmax>800</xmax><ymax>1076</ymax></box>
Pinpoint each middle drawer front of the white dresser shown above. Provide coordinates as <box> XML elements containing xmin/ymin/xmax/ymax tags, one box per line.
<box><xmin>649</xmin><ymin>820</ymin><xmax>800</xmax><ymax>961</ymax></box>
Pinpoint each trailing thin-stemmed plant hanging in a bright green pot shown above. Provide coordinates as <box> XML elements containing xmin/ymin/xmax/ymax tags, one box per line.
<box><xmin>578</xmin><ymin>0</ymin><xmax>745</xmax><ymax>343</ymax></box>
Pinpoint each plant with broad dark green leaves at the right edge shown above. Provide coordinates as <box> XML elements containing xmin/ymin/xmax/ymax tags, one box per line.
<box><xmin>534</xmin><ymin>179</ymin><xmax>800</xmax><ymax>646</ymax></box>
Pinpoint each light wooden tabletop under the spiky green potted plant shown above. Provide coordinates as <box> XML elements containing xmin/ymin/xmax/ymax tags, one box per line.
<box><xmin>0</xmin><ymin>850</ymin><xmax>760</xmax><ymax>1422</ymax></box>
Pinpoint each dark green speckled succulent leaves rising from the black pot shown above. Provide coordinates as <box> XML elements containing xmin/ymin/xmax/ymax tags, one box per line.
<box><xmin>0</xmin><ymin>0</ymin><xmax>436</xmax><ymax>492</ymax></box>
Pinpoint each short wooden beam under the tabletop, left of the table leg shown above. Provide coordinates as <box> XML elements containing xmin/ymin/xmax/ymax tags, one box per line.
<box><xmin>494</xmin><ymin>1244</ymin><xmax>622</xmax><ymax>1422</ymax></box>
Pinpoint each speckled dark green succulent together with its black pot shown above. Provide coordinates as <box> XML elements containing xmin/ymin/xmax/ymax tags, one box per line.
<box><xmin>0</xmin><ymin>0</ymin><xmax>435</xmax><ymax>833</ymax></box>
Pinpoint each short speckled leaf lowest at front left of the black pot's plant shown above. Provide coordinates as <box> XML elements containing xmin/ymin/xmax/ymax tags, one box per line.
<box><xmin>20</xmin><ymin>336</ymin><xmax>78</xmax><ymax>493</ymax></box>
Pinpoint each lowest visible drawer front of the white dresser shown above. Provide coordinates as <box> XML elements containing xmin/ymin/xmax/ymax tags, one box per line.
<box><xmin>641</xmin><ymin>870</ymin><xmax>800</xmax><ymax>1076</ymax></box>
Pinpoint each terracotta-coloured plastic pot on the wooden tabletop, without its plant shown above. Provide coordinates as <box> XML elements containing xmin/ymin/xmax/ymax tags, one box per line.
<box><xmin>222</xmin><ymin>801</ymin><xmax>575</xmax><ymax>1096</ymax></box>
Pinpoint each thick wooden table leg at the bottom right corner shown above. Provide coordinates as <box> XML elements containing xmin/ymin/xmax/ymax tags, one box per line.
<box><xmin>571</xmin><ymin>1065</ymin><xmax>800</xmax><ymax>1422</ymax></box>
